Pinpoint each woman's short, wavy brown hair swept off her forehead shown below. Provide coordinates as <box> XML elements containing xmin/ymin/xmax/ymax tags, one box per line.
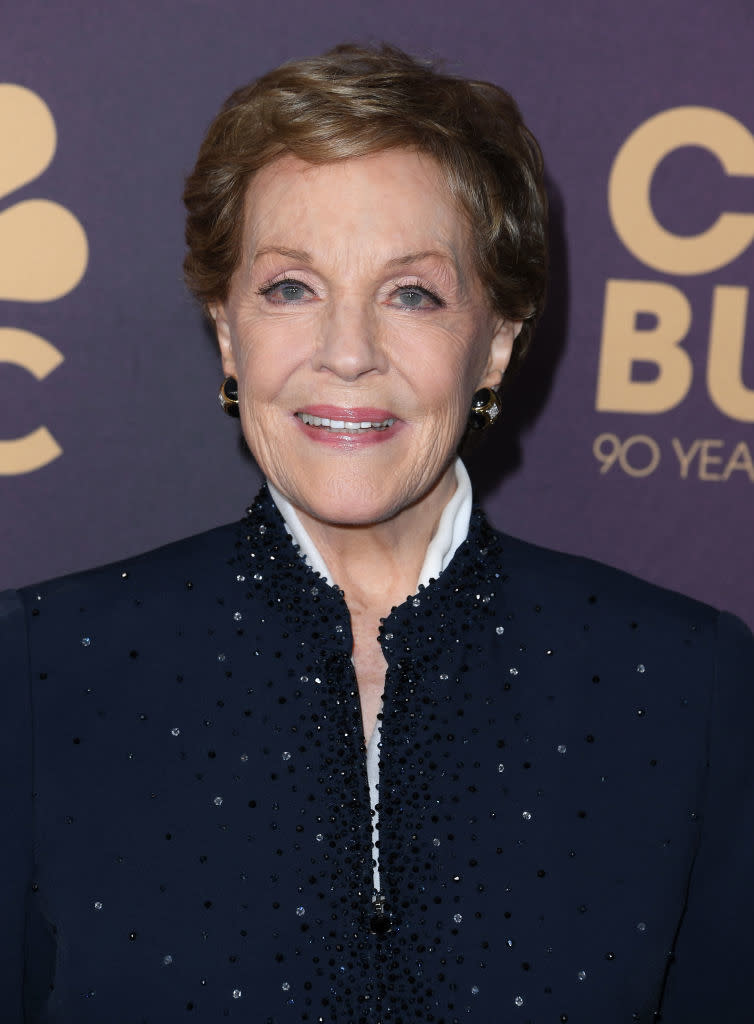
<box><xmin>183</xmin><ymin>45</ymin><xmax>547</xmax><ymax>372</ymax></box>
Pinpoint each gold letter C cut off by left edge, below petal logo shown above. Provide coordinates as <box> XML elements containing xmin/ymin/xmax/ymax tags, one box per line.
<box><xmin>0</xmin><ymin>327</ymin><xmax>62</xmax><ymax>476</ymax></box>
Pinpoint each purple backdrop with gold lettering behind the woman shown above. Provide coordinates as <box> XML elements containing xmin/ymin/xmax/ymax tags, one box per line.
<box><xmin>0</xmin><ymin>0</ymin><xmax>754</xmax><ymax>623</ymax></box>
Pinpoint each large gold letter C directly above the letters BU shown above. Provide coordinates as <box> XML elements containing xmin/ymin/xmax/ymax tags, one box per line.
<box><xmin>608</xmin><ymin>106</ymin><xmax>754</xmax><ymax>274</ymax></box>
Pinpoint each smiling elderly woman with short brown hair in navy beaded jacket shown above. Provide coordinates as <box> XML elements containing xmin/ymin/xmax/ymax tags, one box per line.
<box><xmin>0</xmin><ymin>41</ymin><xmax>754</xmax><ymax>1024</ymax></box>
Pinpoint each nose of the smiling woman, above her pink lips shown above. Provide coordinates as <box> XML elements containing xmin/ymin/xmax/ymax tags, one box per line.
<box><xmin>313</xmin><ymin>303</ymin><xmax>387</xmax><ymax>381</ymax></box>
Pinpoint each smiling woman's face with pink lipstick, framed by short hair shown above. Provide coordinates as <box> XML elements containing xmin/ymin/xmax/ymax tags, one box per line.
<box><xmin>212</xmin><ymin>150</ymin><xmax>519</xmax><ymax>525</ymax></box>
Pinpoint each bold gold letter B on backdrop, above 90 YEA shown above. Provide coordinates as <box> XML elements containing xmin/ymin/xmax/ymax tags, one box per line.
<box><xmin>597</xmin><ymin>280</ymin><xmax>694</xmax><ymax>413</ymax></box>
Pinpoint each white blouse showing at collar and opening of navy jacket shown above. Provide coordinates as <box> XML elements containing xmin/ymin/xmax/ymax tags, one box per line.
<box><xmin>267</xmin><ymin>459</ymin><xmax>471</xmax><ymax>892</ymax></box>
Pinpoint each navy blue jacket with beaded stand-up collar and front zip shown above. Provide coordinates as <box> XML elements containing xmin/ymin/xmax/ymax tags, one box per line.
<box><xmin>0</xmin><ymin>493</ymin><xmax>754</xmax><ymax>1024</ymax></box>
